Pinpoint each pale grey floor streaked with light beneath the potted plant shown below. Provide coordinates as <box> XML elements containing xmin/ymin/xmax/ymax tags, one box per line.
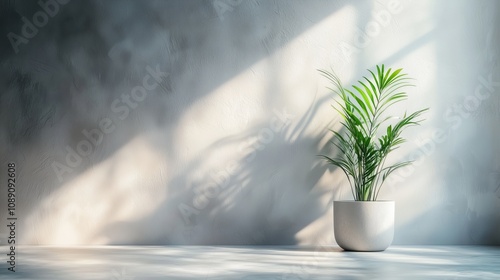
<box><xmin>0</xmin><ymin>246</ymin><xmax>500</xmax><ymax>280</ymax></box>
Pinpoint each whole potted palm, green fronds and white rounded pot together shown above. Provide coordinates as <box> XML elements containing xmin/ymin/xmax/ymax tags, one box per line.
<box><xmin>319</xmin><ymin>65</ymin><xmax>428</xmax><ymax>251</ymax></box>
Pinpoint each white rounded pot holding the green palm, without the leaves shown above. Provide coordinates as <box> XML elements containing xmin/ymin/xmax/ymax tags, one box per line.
<box><xmin>333</xmin><ymin>200</ymin><xmax>395</xmax><ymax>252</ymax></box>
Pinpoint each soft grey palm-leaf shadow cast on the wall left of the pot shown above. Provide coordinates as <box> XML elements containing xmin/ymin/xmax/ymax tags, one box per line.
<box><xmin>96</xmin><ymin>98</ymin><xmax>337</xmax><ymax>245</ymax></box>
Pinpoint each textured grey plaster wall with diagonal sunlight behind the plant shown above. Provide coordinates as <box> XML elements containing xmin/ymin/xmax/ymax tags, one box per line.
<box><xmin>0</xmin><ymin>0</ymin><xmax>500</xmax><ymax>244</ymax></box>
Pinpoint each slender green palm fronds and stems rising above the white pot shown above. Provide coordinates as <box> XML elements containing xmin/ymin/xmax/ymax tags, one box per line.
<box><xmin>319</xmin><ymin>64</ymin><xmax>428</xmax><ymax>201</ymax></box>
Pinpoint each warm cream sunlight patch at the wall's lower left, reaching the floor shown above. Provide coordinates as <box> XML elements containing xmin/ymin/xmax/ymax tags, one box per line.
<box><xmin>22</xmin><ymin>136</ymin><xmax>165</xmax><ymax>245</ymax></box>
